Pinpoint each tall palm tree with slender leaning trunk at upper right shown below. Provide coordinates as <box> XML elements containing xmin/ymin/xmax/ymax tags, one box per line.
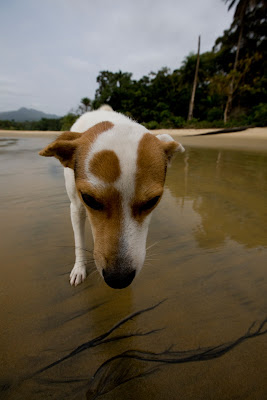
<box><xmin>224</xmin><ymin>0</ymin><xmax>260</xmax><ymax>122</ymax></box>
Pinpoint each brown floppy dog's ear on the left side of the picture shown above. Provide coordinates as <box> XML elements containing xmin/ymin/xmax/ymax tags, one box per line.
<box><xmin>39</xmin><ymin>132</ymin><xmax>82</xmax><ymax>169</ymax></box>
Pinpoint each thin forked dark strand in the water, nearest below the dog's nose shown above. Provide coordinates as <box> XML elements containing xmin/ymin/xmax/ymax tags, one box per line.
<box><xmin>33</xmin><ymin>299</ymin><xmax>166</xmax><ymax>376</ymax></box>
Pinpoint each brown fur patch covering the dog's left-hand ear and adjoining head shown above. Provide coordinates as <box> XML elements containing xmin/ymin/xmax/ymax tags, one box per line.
<box><xmin>39</xmin><ymin>121</ymin><xmax>114</xmax><ymax>169</ymax></box>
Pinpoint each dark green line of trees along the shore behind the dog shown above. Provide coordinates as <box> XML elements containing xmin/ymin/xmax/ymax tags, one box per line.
<box><xmin>0</xmin><ymin>0</ymin><xmax>267</xmax><ymax>130</ymax></box>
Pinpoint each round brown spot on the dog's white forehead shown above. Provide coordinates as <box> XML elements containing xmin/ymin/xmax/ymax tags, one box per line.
<box><xmin>90</xmin><ymin>150</ymin><xmax>121</xmax><ymax>183</ymax></box>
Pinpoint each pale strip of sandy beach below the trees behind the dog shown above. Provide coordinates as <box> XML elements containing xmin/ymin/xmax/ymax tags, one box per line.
<box><xmin>0</xmin><ymin>127</ymin><xmax>267</xmax><ymax>152</ymax></box>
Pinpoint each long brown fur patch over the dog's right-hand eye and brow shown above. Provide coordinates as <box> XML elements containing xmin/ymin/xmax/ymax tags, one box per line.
<box><xmin>132</xmin><ymin>133</ymin><xmax>167</xmax><ymax>223</ymax></box>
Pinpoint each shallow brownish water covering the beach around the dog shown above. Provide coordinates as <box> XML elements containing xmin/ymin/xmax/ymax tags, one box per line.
<box><xmin>0</xmin><ymin>137</ymin><xmax>267</xmax><ymax>400</ymax></box>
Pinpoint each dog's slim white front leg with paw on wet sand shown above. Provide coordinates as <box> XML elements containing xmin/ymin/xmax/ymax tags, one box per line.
<box><xmin>64</xmin><ymin>168</ymin><xmax>87</xmax><ymax>286</ymax></box>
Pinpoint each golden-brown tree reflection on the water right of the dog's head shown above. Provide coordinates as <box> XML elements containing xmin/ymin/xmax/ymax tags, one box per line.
<box><xmin>167</xmin><ymin>149</ymin><xmax>267</xmax><ymax>248</ymax></box>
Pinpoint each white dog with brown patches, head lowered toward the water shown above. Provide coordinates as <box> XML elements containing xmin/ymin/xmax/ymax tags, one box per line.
<box><xmin>39</xmin><ymin>105</ymin><xmax>184</xmax><ymax>289</ymax></box>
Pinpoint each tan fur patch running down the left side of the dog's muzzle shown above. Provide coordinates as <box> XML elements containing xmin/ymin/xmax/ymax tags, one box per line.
<box><xmin>76</xmin><ymin>179</ymin><xmax>123</xmax><ymax>269</ymax></box>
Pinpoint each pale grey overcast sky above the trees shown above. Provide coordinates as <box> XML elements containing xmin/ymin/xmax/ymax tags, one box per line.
<box><xmin>0</xmin><ymin>0</ymin><xmax>234</xmax><ymax>115</ymax></box>
